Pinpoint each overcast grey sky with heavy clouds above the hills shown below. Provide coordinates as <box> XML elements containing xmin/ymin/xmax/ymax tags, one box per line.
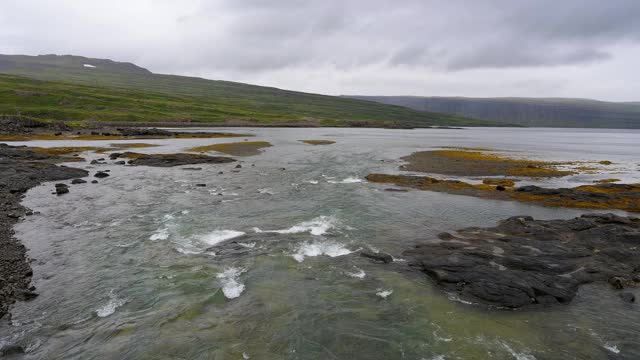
<box><xmin>0</xmin><ymin>0</ymin><xmax>640</xmax><ymax>101</ymax></box>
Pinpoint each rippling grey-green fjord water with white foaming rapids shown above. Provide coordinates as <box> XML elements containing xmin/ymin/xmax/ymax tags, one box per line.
<box><xmin>0</xmin><ymin>128</ymin><xmax>640</xmax><ymax>359</ymax></box>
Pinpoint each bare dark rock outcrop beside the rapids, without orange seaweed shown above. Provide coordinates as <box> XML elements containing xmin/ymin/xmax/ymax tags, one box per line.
<box><xmin>404</xmin><ymin>214</ymin><xmax>640</xmax><ymax>308</ymax></box>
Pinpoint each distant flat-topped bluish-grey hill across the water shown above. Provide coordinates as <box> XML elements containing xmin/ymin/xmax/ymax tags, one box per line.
<box><xmin>345</xmin><ymin>96</ymin><xmax>640</xmax><ymax>129</ymax></box>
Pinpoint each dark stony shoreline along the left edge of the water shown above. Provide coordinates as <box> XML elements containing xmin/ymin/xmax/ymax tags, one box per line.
<box><xmin>0</xmin><ymin>144</ymin><xmax>88</xmax><ymax>318</ymax></box>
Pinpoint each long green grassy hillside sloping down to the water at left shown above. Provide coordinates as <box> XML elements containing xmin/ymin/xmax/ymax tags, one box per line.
<box><xmin>0</xmin><ymin>55</ymin><xmax>492</xmax><ymax>126</ymax></box>
